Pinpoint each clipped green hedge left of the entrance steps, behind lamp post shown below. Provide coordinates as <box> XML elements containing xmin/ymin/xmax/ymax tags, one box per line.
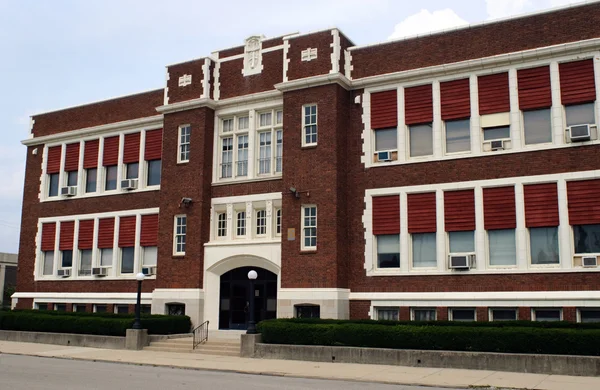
<box><xmin>0</xmin><ymin>310</ymin><xmax>191</xmax><ymax>336</ymax></box>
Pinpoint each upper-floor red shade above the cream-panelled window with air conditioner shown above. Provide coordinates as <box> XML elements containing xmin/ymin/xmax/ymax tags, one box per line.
<box><xmin>477</xmin><ymin>72</ymin><xmax>510</xmax><ymax>115</ymax></box>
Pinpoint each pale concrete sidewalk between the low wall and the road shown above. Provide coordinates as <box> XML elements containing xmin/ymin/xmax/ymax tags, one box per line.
<box><xmin>0</xmin><ymin>341</ymin><xmax>600</xmax><ymax>390</ymax></box>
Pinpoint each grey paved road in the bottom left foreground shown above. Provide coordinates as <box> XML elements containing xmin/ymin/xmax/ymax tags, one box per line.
<box><xmin>0</xmin><ymin>354</ymin><xmax>464</xmax><ymax>390</ymax></box>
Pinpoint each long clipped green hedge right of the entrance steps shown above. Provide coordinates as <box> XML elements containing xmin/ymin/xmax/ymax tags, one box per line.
<box><xmin>258</xmin><ymin>319</ymin><xmax>600</xmax><ymax>356</ymax></box>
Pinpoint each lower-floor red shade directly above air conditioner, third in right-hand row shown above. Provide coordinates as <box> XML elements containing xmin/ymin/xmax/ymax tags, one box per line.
<box><xmin>444</xmin><ymin>190</ymin><xmax>475</xmax><ymax>232</ymax></box>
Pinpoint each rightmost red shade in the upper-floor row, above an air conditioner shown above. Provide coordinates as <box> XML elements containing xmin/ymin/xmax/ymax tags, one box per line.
<box><xmin>558</xmin><ymin>59</ymin><xmax>596</xmax><ymax>105</ymax></box>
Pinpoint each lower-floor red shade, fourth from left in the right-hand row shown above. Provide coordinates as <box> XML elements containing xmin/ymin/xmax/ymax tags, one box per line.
<box><xmin>483</xmin><ymin>187</ymin><xmax>517</xmax><ymax>230</ymax></box>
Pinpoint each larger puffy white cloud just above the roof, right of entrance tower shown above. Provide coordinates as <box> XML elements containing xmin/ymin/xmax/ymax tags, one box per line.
<box><xmin>388</xmin><ymin>8</ymin><xmax>468</xmax><ymax>39</ymax></box>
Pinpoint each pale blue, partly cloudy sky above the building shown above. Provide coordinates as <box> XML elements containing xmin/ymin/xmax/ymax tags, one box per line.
<box><xmin>0</xmin><ymin>0</ymin><xmax>577</xmax><ymax>253</ymax></box>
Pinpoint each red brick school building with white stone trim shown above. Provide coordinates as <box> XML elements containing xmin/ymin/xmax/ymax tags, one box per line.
<box><xmin>13</xmin><ymin>3</ymin><xmax>600</xmax><ymax>329</ymax></box>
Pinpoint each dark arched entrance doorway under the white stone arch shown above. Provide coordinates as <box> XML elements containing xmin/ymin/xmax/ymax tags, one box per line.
<box><xmin>219</xmin><ymin>267</ymin><xmax>277</xmax><ymax>329</ymax></box>
